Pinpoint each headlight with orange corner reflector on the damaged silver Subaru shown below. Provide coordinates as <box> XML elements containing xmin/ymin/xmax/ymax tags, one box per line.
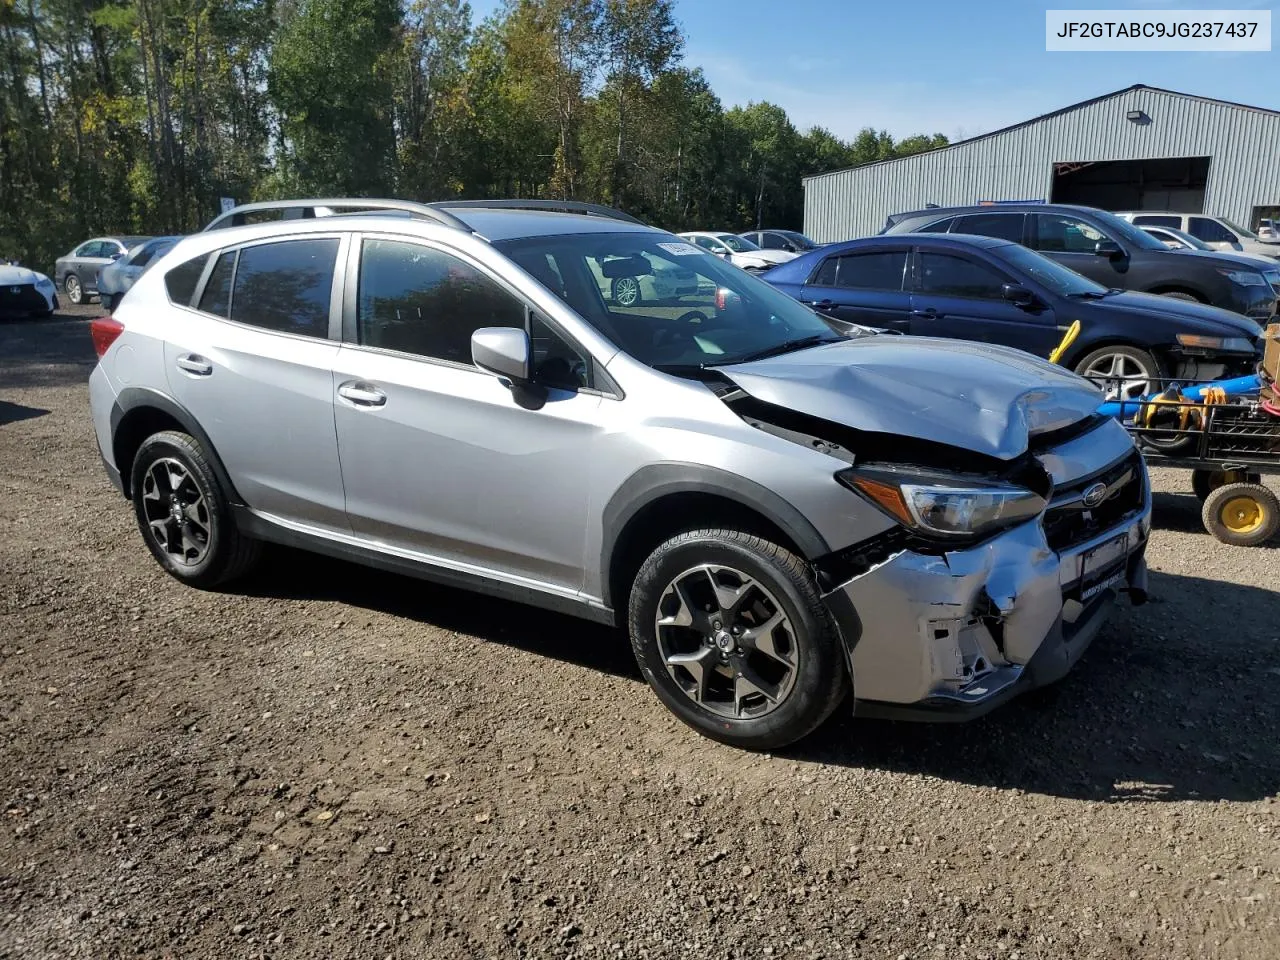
<box><xmin>836</xmin><ymin>467</ymin><xmax>1046</xmax><ymax>539</ymax></box>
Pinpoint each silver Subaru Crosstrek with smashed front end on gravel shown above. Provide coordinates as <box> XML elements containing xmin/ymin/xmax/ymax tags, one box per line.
<box><xmin>90</xmin><ymin>200</ymin><xmax>1151</xmax><ymax>749</ymax></box>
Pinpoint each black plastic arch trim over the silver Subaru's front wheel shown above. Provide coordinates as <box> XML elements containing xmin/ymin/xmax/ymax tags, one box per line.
<box><xmin>600</xmin><ymin>463</ymin><xmax>831</xmax><ymax>605</ymax></box>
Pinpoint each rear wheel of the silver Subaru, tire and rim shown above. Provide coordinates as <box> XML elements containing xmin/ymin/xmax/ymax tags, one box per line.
<box><xmin>129</xmin><ymin>430</ymin><xmax>261</xmax><ymax>589</ymax></box>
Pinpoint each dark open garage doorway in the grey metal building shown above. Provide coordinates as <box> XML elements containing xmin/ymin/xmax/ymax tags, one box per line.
<box><xmin>1052</xmin><ymin>156</ymin><xmax>1208</xmax><ymax>214</ymax></box>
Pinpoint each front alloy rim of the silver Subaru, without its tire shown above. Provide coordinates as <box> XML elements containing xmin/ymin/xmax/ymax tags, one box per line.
<box><xmin>654</xmin><ymin>564</ymin><xmax>799</xmax><ymax>719</ymax></box>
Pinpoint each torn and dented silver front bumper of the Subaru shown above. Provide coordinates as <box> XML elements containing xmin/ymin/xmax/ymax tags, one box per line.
<box><xmin>824</xmin><ymin>471</ymin><xmax>1151</xmax><ymax>721</ymax></box>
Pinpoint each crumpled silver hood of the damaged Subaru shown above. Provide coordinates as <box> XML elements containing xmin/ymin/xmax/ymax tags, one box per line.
<box><xmin>718</xmin><ymin>335</ymin><xmax>1102</xmax><ymax>460</ymax></box>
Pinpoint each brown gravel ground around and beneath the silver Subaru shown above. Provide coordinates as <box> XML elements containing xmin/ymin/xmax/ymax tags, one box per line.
<box><xmin>0</xmin><ymin>307</ymin><xmax>1280</xmax><ymax>960</ymax></box>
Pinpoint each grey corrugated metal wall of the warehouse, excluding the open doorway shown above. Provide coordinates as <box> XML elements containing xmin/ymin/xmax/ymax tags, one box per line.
<box><xmin>804</xmin><ymin>90</ymin><xmax>1280</xmax><ymax>243</ymax></box>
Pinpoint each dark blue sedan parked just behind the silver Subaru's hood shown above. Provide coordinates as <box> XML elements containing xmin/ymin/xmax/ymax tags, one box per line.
<box><xmin>762</xmin><ymin>233</ymin><xmax>1261</xmax><ymax>397</ymax></box>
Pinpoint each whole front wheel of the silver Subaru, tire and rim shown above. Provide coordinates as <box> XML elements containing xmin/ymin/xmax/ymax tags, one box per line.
<box><xmin>627</xmin><ymin>530</ymin><xmax>850</xmax><ymax>750</ymax></box>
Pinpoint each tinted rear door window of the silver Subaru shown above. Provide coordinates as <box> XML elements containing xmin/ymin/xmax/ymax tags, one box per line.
<box><xmin>230</xmin><ymin>238</ymin><xmax>338</xmax><ymax>338</ymax></box>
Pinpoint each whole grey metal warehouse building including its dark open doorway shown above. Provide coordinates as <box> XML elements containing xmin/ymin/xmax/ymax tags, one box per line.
<box><xmin>804</xmin><ymin>84</ymin><xmax>1280</xmax><ymax>242</ymax></box>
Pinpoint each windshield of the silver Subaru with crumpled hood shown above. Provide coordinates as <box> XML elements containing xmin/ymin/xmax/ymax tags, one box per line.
<box><xmin>494</xmin><ymin>230</ymin><xmax>870</xmax><ymax>375</ymax></box>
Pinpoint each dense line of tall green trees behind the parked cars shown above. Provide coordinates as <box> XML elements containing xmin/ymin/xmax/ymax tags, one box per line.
<box><xmin>0</xmin><ymin>0</ymin><xmax>947</xmax><ymax>268</ymax></box>
